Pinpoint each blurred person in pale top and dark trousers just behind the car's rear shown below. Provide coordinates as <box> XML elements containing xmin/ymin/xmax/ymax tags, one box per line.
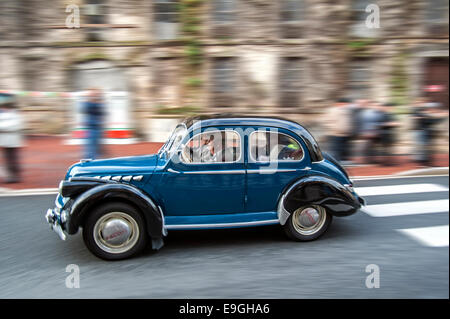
<box><xmin>325</xmin><ymin>98</ymin><xmax>352</xmax><ymax>161</ymax></box>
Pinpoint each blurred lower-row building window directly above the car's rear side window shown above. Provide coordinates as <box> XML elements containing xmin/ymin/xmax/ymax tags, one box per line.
<box><xmin>279</xmin><ymin>57</ymin><xmax>303</xmax><ymax>107</ymax></box>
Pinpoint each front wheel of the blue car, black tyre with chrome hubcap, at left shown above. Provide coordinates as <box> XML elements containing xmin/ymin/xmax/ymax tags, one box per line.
<box><xmin>83</xmin><ymin>203</ymin><xmax>148</xmax><ymax>260</ymax></box>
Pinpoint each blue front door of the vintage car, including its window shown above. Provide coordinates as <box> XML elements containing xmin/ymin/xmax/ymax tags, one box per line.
<box><xmin>158</xmin><ymin>127</ymin><xmax>245</xmax><ymax>216</ymax></box>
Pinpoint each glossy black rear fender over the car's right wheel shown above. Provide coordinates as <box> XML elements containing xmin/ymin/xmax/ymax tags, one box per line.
<box><xmin>278</xmin><ymin>175</ymin><xmax>361</xmax><ymax>225</ymax></box>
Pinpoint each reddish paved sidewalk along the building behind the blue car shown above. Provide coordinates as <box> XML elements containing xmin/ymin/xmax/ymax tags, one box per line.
<box><xmin>0</xmin><ymin>136</ymin><xmax>448</xmax><ymax>192</ymax></box>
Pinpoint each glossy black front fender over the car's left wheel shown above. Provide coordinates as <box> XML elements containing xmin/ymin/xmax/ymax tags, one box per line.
<box><xmin>66</xmin><ymin>183</ymin><xmax>165</xmax><ymax>238</ymax></box>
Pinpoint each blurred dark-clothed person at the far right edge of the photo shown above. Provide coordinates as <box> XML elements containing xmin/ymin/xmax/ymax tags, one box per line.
<box><xmin>412</xmin><ymin>98</ymin><xmax>448</xmax><ymax>166</ymax></box>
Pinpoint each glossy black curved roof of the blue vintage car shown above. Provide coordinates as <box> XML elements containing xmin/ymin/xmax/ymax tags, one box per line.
<box><xmin>182</xmin><ymin>113</ymin><xmax>323</xmax><ymax>162</ymax></box>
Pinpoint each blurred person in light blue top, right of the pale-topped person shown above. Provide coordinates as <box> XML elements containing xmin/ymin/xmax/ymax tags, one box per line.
<box><xmin>360</xmin><ymin>102</ymin><xmax>381</xmax><ymax>164</ymax></box>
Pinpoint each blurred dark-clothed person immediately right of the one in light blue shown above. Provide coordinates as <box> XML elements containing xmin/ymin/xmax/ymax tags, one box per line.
<box><xmin>378</xmin><ymin>103</ymin><xmax>399</xmax><ymax>166</ymax></box>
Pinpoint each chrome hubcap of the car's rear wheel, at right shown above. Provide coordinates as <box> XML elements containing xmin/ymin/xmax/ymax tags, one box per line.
<box><xmin>292</xmin><ymin>205</ymin><xmax>326</xmax><ymax>235</ymax></box>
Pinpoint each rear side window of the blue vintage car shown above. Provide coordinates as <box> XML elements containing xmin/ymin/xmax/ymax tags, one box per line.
<box><xmin>249</xmin><ymin>131</ymin><xmax>303</xmax><ymax>162</ymax></box>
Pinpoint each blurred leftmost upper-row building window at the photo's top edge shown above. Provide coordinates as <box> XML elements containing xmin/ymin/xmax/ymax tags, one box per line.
<box><xmin>82</xmin><ymin>0</ymin><xmax>106</xmax><ymax>41</ymax></box>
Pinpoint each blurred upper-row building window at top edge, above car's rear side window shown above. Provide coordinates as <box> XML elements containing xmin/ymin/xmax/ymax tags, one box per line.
<box><xmin>280</xmin><ymin>0</ymin><xmax>304</xmax><ymax>39</ymax></box>
